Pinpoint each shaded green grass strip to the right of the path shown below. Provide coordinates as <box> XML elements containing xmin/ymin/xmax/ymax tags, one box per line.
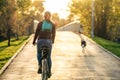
<box><xmin>93</xmin><ymin>37</ymin><xmax>120</xmax><ymax>57</ymax></box>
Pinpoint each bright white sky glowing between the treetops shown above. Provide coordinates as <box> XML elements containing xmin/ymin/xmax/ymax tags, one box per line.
<box><xmin>44</xmin><ymin>0</ymin><xmax>70</xmax><ymax>18</ymax></box>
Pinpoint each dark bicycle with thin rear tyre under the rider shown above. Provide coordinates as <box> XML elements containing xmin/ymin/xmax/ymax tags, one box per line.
<box><xmin>41</xmin><ymin>46</ymin><xmax>50</xmax><ymax>80</ymax></box>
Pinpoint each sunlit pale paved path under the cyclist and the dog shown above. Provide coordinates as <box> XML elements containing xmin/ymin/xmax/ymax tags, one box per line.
<box><xmin>0</xmin><ymin>31</ymin><xmax>120</xmax><ymax>80</ymax></box>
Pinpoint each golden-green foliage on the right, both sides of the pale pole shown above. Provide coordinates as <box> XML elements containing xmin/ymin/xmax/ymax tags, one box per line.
<box><xmin>70</xmin><ymin>0</ymin><xmax>120</xmax><ymax>40</ymax></box>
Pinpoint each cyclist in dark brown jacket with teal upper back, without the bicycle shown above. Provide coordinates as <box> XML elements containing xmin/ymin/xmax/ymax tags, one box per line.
<box><xmin>33</xmin><ymin>11</ymin><xmax>56</xmax><ymax>77</ymax></box>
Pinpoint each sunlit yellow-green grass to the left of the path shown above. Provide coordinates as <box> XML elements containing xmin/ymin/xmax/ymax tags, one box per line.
<box><xmin>0</xmin><ymin>36</ymin><xmax>28</xmax><ymax>69</ymax></box>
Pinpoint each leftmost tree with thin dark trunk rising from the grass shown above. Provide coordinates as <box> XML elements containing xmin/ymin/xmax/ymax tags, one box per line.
<box><xmin>1</xmin><ymin>0</ymin><xmax>16</xmax><ymax>46</ymax></box>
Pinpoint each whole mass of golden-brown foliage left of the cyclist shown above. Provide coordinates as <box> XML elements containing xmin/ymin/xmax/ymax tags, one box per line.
<box><xmin>0</xmin><ymin>0</ymin><xmax>44</xmax><ymax>40</ymax></box>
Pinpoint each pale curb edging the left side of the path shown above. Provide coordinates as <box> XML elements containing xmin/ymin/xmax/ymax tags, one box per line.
<box><xmin>0</xmin><ymin>35</ymin><xmax>32</xmax><ymax>75</ymax></box>
